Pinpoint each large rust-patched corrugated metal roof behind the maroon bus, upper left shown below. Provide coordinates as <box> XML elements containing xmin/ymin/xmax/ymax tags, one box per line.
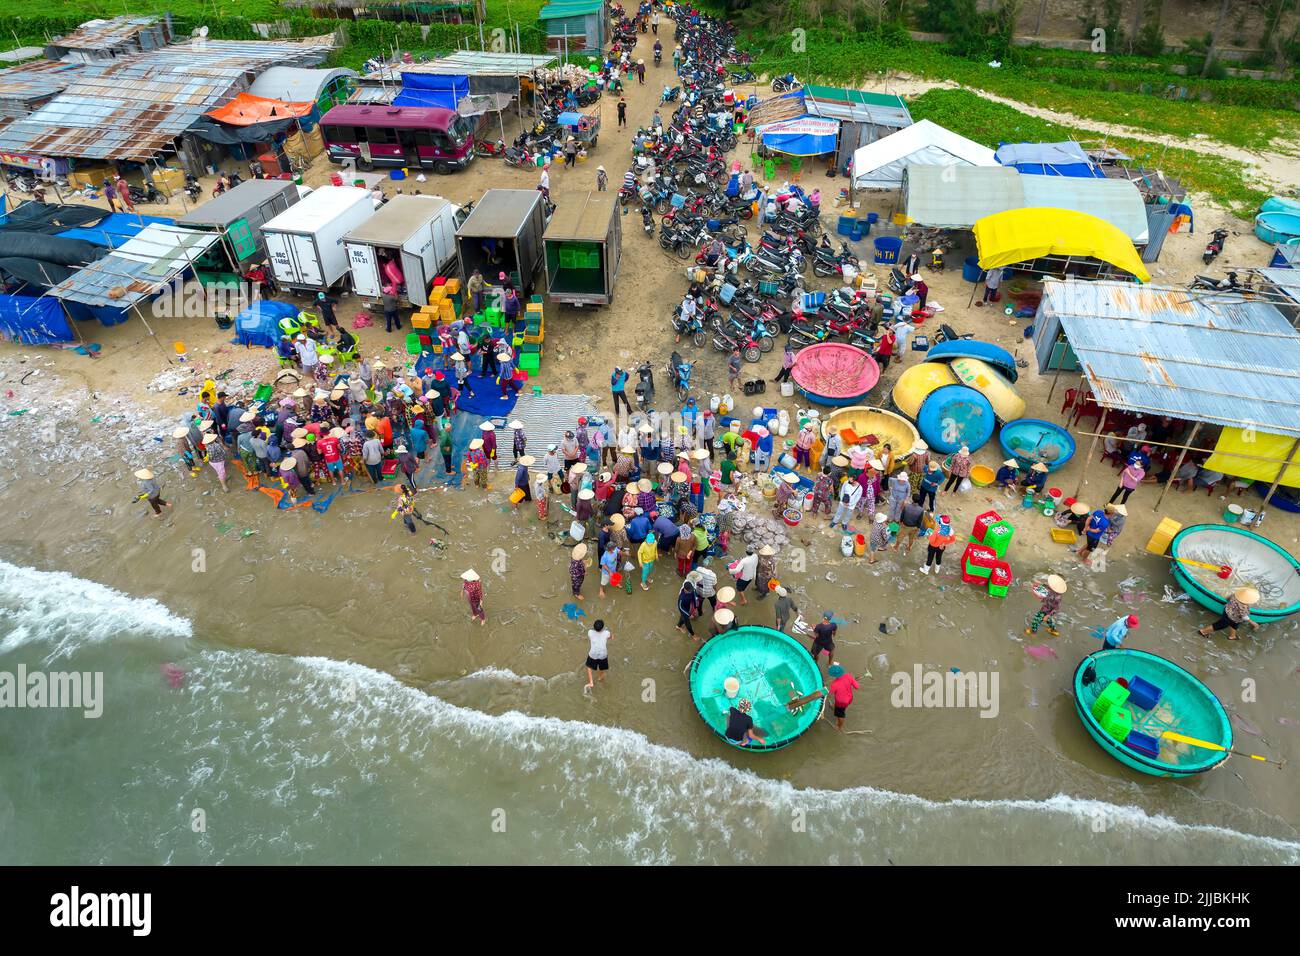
<box><xmin>0</xmin><ymin>36</ymin><xmax>333</xmax><ymax>160</ymax></box>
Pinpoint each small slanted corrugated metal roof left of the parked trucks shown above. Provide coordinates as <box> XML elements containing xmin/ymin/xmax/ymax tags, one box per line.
<box><xmin>51</xmin><ymin>224</ymin><xmax>221</xmax><ymax>310</ymax></box>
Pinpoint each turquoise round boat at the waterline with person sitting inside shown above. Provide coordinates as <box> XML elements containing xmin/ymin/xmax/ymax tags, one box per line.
<box><xmin>690</xmin><ymin>627</ymin><xmax>824</xmax><ymax>750</ymax></box>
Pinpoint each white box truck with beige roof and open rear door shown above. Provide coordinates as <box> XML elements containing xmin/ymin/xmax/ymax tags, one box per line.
<box><xmin>343</xmin><ymin>196</ymin><xmax>464</xmax><ymax>306</ymax></box>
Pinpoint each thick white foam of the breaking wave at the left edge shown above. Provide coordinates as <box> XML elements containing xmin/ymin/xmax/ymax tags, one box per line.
<box><xmin>0</xmin><ymin>561</ymin><xmax>192</xmax><ymax>661</ymax></box>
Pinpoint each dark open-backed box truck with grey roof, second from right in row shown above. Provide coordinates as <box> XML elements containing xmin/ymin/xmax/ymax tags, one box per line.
<box><xmin>456</xmin><ymin>189</ymin><xmax>546</xmax><ymax>297</ymax></box>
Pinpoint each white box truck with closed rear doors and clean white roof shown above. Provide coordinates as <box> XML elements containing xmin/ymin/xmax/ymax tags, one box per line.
<box><xmin>261</xmin><ymin>186</ymin><xmax>374</xmax><ymax>291</ymax></box>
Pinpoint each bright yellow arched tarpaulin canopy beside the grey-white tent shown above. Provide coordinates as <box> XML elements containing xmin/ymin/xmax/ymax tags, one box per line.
<box><xmin>975</xmin><ymin>208</ymin><xmax>1151</xmax><ymax>282</ymax></box>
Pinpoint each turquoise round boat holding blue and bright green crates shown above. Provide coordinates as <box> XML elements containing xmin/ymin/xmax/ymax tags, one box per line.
<box><xmin>1074</xmin><ymin>648</ymin><xmax>1232</xmax><ymax>777</ymax></box>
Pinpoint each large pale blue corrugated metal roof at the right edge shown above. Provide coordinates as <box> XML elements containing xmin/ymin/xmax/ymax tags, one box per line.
<box><xmin>1039</xmin><ymin>278</ymin><xmax>1300</xmax><ymax>437</ymax></box>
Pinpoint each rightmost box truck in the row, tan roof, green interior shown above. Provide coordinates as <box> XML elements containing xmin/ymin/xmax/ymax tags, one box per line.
<box><xmin>542</xmin><ymin>193</ymin><xmax>623</xmax><ymax>307</ymax></box>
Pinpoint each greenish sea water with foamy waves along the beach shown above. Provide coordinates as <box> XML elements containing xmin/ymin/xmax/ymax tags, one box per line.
<box><xmin>0</xmin><ymin>562</ymin><xmax>1300</xmax><ymax>864</ymax></box>
